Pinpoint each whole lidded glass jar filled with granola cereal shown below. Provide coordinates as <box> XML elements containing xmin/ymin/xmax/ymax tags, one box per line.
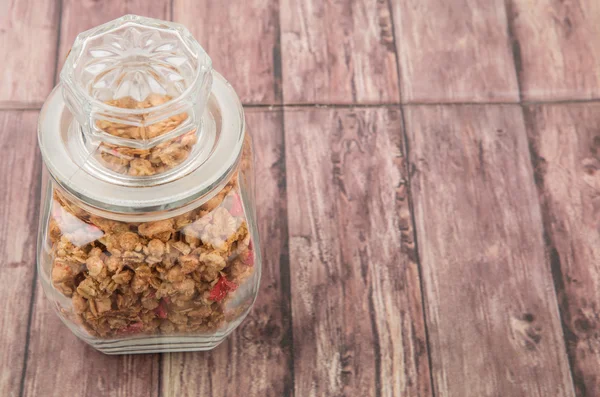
<box><xmin>37</xmin><ymin>15</ymin><xmax>261</xmax><ymax>354</ymax></box>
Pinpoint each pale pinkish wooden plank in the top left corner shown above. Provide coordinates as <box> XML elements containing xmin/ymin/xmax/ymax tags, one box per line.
<box><xmin>0</xmin><ymin>0</ymin><xmax>58</xmax><ymax>107</ymax></box>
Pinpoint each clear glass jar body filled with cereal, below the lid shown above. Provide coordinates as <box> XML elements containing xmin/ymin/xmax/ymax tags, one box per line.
<box><xmin>38</xmin><ymin>134</ymin><xmax>261</xmax><ymax>354</ymax></box>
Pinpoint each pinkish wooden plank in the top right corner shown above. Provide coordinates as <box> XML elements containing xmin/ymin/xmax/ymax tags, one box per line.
<box><xmin>507</xmin><ymin>0</ymin><xmax>600</xmax><ymax>101</ymax></box>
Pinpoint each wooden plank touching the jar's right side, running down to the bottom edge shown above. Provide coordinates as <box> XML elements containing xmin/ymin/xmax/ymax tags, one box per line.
<box><xmin>162</xmin><ymin>110</ymin><xmax>293</xmax><ymax>397</ymax></box>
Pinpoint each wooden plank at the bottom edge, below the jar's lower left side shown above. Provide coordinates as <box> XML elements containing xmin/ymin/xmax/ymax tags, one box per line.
<box><xmin>23</xmin><ymin>281</ymin><xmax>159</xmax><ymax>397</ymax></box>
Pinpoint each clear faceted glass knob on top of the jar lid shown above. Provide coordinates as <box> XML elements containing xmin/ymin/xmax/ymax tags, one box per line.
<box><xmin>60</xmin><ymin>15</ymin><xmax>212</xmax><ymax>149</ymax></box>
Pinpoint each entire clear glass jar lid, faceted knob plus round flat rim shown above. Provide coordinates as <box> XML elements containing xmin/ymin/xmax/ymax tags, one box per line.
<box><xmin>38</xmin><ymin>15</ymin><xmax>245</xmax><ymax>214</ymax></box>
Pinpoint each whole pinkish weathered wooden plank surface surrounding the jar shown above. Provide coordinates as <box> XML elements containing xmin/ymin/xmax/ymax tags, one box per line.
<box><xmin>0</xmin><ymin>0</ymin><xmax>600</xmax><ymax>397</ymax></box>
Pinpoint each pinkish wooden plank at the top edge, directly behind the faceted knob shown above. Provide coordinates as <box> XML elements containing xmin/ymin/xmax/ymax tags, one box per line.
<box><xmin>57</xmin><ymin>0</ymin><xmax>171</xmax><ymax>73</ymax></box>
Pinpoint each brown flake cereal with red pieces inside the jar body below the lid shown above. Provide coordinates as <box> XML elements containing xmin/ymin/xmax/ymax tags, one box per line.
<box><xmin>48</xmin><ymin>156</ymin><xmax>254</xmax><ymax>337</ymax></box>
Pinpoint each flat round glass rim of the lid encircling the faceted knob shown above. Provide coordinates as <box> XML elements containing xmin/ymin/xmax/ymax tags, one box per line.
<box><xmin>38</xmin><ymin>71</ymin><xmax>245</xmax><ymax>214</ymax></box>
